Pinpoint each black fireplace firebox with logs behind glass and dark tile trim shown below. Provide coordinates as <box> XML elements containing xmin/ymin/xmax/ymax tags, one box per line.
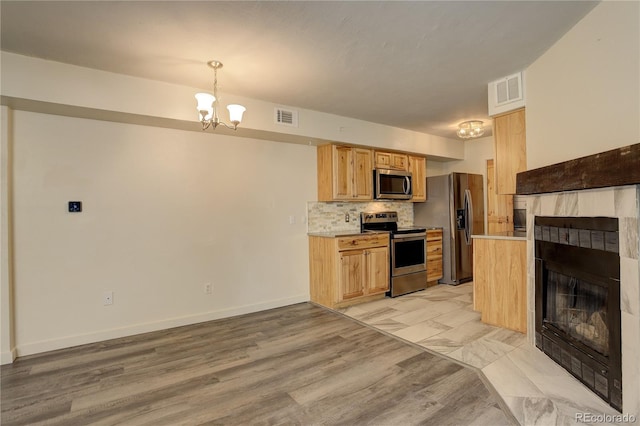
<box><xmin>534</xmin><ymin>216</ymin><xmax>622</xmax><ymax>411</ymax></box>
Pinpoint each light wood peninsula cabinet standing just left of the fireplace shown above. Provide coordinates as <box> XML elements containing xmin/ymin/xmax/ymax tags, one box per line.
<box><xmin>472</xmin><ymin>231</ymin><xmax>527</xmax><ymax>333</ymax></box>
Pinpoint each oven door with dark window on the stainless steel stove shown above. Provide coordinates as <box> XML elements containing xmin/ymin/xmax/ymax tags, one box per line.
<box><xmin>391</xmin><ymin>232</ymin><xmax>427</xmax><ymax>277</ymax></box>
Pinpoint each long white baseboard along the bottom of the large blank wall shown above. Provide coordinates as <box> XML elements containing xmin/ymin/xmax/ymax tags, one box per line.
<box><xmin>16</xmin><ymin>294</ymin><xmax>309</xmax><ymax>358</ymax></box>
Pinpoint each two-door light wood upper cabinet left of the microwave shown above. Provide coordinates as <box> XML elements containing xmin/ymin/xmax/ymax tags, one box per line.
<box><xmin>318</xmin><ymin>144</ymin><xmax>373</xmax><ymax>201</ymax></box>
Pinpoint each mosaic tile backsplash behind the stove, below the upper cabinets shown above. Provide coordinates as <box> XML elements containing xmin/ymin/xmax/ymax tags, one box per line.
<box><xmin>307</xmin><ymin>201</ymin><xmax>413</xmax><ymax>232</ymax></box>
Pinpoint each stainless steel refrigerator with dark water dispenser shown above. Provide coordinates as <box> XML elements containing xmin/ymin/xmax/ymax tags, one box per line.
<box><xmin>413</xmin><ymin>173</ymin><xmax>484</xmax><ymax>285</ymax></box>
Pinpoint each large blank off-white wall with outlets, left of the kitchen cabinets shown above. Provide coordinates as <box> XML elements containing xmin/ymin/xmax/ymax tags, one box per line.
<box><xmin>12</xmin><ymin>111</ymin><xmax>316</xmax><ymax>355</ymax></box>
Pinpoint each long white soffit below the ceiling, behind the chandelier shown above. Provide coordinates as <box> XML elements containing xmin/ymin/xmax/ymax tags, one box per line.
<box><xmin>0</xmin><ymin>52</ymin><xmax>464</xmax><ymax>159</ymax></box>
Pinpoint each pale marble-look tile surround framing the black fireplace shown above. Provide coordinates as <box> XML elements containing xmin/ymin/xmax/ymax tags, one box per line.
<box><xmin>525</xmin><ymin>185</ymin><xmax>640</xmax><ymax>417</ymax></box>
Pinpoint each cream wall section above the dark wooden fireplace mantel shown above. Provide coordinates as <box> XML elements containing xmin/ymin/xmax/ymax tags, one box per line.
<box><xmin>525</xmin><ymin>1</ymin><xmax>640</xmax><ymax>169</ymax></box>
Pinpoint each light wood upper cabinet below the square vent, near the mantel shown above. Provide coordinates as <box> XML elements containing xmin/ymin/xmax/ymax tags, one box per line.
<box><xmin>493</xmin><ymin>108</ymin><xmax>527</xmax><ymax>194</ymax></box>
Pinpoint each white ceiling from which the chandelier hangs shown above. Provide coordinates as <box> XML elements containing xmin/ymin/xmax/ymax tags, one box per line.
<box><xmin>0</xmin><ymin>0</ymin><xmax>597</xmax><ymax>138</ymax></box>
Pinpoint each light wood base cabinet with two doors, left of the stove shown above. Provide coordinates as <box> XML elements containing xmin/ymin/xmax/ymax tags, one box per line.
<box><xmin>309</xmin><ymin>234</ymin><xmax>389</xmax><ymax>308</ymax></box>
